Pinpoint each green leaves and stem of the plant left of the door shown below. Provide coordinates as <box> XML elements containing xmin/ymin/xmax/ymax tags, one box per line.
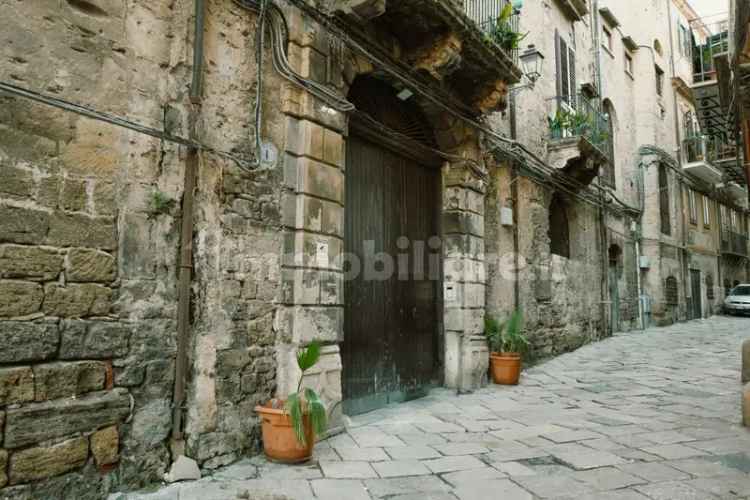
<box><xmin>284</xmin><ymin>340</ymin><xmax>327</xmax><ymax>446</ymax></box>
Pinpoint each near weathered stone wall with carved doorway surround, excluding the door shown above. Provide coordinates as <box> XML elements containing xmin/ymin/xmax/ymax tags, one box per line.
<box><xmin>0</xmin><ymin>0</ymin><xmax>521</xmax><ymax>499</ymax></box>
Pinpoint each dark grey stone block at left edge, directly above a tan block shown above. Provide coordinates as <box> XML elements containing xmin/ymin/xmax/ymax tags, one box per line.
<box><xmin>0</xmin><ymin>320</ymin><xmax>60</xmax><ymax>363</ymax></box>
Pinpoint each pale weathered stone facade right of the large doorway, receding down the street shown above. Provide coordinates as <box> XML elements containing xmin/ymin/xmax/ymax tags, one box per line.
<box><xmin>487</xmin><ymin>0</ymin><xmax>748</xmax><ymax>342</ymax></box>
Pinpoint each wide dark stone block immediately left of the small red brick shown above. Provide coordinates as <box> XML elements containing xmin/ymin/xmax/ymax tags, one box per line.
<box><xmin>34</xmin><ymin>361</ymin><xmax>107</xmax><ymax>401</ymax></box>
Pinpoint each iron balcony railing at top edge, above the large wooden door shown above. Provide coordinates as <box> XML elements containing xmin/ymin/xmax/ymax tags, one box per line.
<box><xmin>464</xmin><ymin>0</ymin><xmax>526</xmax><ymax>65</ymax></box>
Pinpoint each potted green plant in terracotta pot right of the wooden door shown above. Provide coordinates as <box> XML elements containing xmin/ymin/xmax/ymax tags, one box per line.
<box><xmin>484</xmin><ymin>311</ymin><xmax>529</xmax><ymax>385</ymax></box>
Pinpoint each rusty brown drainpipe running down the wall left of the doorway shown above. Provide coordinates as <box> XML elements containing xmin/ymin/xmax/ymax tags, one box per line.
<box><xmin>172</xmin><ymin>0</ymin><xmax>205</xmax><ymax>455</ymax></box>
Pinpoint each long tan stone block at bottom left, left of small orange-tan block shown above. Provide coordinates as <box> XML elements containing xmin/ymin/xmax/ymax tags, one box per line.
<box><xmin>10</xmin><ymin>438</ymin><xmax>89</xmax><ymax>484</ymax></box>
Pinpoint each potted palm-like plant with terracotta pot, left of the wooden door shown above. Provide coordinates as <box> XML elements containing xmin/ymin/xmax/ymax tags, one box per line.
<box><xmin>255</xmin><ymin>341</ymin><xmax>327</xmax><ymax>464</ymax></box>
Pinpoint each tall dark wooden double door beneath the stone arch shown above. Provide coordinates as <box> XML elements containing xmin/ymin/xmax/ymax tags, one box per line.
<box><xmin>341</xmin><ymin>135</ymin><xmax>440</xmax><ymax>415</ymax></box>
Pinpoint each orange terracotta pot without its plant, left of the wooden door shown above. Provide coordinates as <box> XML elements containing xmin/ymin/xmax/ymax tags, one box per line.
<box><xmin>255</xmin><ymin>405</ymin><xmax>315</xmax><ymax>464</ymax></box>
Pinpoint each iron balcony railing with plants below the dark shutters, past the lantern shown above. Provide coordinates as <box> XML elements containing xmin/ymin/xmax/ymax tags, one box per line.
<box><xmin>548</xmin><ymin>94</ymin><xmax>614</xmax><ymax>162</ymax></box>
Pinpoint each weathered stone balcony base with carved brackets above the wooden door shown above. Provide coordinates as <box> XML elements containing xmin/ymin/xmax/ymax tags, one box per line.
<box><xmin>336</xmin><ymin>0</ymin><xmax>523</xmax><ymax>115</ymax></box>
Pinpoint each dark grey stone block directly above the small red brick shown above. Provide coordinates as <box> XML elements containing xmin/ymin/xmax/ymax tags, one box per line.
<box><xmin>60</xmin><ymin>321</ymin><xmax>132</xmax><ymax>359</ymax></box>
